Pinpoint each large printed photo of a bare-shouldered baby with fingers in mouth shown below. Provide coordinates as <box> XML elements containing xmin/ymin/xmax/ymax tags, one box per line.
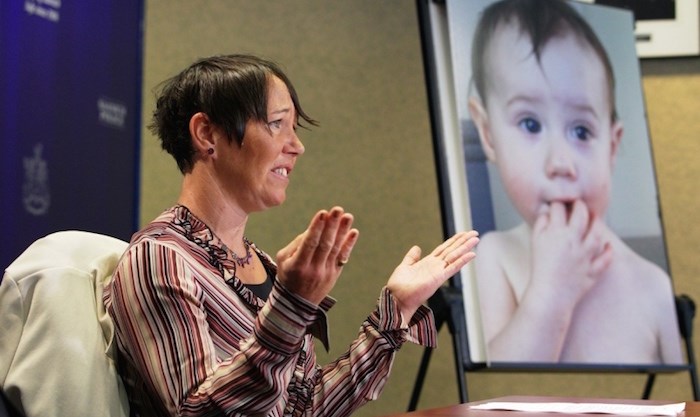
<box><xmin>444</xmin><ymin>0</ymin><xmax>684</xmax><ymax>365</ymax></box>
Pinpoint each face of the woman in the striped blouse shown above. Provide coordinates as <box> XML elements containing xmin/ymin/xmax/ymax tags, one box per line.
<box><xmin>217</xmin><ymin>76</ymin><xmax>304</xmax><ymax>213</ymax></box>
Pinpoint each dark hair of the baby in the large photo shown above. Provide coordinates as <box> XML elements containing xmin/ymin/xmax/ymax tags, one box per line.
<box><xmin>471</xmin><ymin>0</ymin><xmax>617</xmax><ymax>120</ymax></box>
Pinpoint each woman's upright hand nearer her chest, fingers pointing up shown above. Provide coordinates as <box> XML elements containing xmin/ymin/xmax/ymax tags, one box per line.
<box><xmin>276</xmin><ymin>207</ymin><xmax>359</xmax><ymax>305</ymax></box>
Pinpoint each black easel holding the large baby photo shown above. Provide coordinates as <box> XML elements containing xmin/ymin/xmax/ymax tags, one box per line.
<box><xmin>408</xmin><ymin>0</ymin><xmax>700</xmax><ymax>411</ymax></box>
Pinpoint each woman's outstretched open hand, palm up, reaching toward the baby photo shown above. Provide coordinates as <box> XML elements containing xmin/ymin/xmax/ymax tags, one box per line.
<box><xmin>387</xmin><ymin>230</ymin><xmax>479</xmax><ymax>323</ymax></box>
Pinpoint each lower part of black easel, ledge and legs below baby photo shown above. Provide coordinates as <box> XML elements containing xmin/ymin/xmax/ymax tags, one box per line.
<box><xmin>408</xmin><ymin>286</ymin><xmax>700</xmax><ymax>411</ymax></box>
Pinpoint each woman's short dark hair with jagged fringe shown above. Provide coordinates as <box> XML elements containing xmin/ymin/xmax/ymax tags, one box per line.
<box><xmin>148</xmin><ymin>54</ymin><xmax>318</xmax><ymax>173</ymax></box>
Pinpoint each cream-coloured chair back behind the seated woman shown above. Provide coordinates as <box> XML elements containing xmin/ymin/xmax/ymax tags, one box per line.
<box><xmin>0</xmin><ymin>231</ymin><xmax>129</xmax><ymax>417</ymax></box>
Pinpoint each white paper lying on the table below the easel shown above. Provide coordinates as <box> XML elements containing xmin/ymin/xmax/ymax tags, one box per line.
<box><xmin>470</xmin><ymin>402</ymin><xmax>685</xmax><ymax>417</ymax></box>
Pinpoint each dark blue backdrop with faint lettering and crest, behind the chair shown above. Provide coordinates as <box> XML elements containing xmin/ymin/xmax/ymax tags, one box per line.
<box><xmin>0</xmin><ymin>0</ymin><xmax>143</xmax><ymax>270</ymax></box>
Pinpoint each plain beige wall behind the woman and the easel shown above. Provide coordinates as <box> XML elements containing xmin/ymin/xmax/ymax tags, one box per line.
<box><xmin>141</xmin><ymin>0</ymin><xmax>700</xmax><ymax>416</ymax></box>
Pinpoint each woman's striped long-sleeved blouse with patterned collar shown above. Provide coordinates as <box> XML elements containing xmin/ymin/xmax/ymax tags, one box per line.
<box><xmin>104</xmin><ymin>206</ymin><xmax>436</xmax><ymax>417</ymax></box>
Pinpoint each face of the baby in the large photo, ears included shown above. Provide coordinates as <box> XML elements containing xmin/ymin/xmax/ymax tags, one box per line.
<box><xmin>476</xmin><ymin>25</ymin><xmax>622</xmax><ymax>224</ymax></box>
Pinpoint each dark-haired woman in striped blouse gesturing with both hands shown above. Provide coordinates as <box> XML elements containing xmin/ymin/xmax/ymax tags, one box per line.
<box><xmin>105</xmin><ymin>55</ymin><xmax>478</xmax><ymax>416</ymax></box>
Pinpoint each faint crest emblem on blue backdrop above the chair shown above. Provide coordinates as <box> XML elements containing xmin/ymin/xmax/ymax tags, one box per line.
<box><xmin>22</xmin><ymin>143</ymin><xmax>51</xmax><ymax>216</ymax></box>
